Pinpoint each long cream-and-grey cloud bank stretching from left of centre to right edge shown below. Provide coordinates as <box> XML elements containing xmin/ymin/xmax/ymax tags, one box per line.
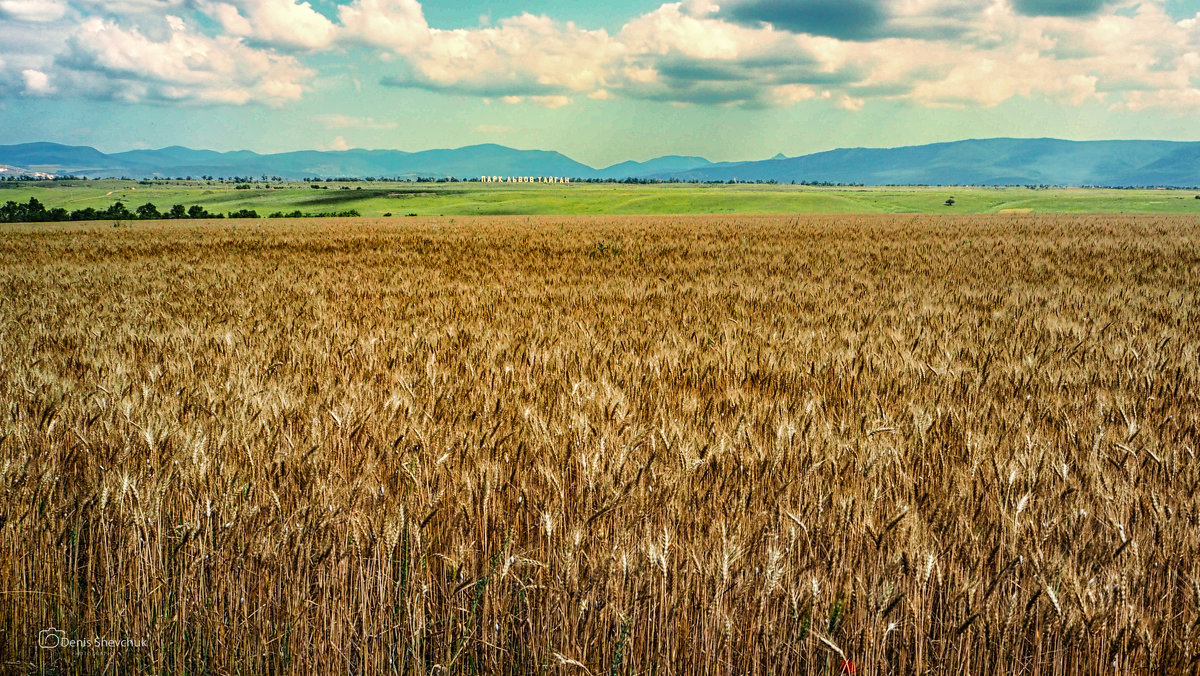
<box><xmin>324</xmin><ymin>0</ymin><xmax>1200</xmax><ymax>110</ymax></box>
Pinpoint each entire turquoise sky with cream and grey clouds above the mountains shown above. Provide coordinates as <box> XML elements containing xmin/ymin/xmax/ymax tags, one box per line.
<box><xmin>0</xmin><ymin>0</ymin><xmax>1200</xmax><ymax>166</ymax></box>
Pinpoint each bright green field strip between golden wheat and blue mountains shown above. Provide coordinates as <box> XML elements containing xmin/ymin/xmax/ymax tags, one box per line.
<box><xmin>0</xmin><ymin>180</ymin><xmax>1200</xmax><ymax>216</ymax></box>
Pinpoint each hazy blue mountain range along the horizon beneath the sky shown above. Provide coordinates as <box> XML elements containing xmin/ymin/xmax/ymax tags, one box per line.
<box><xmin>7</xmin><ymin>138</ymin><xmax>1200</xmax><ymax>187</ymax></box>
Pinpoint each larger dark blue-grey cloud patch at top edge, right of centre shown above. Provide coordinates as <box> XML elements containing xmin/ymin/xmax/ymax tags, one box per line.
<box><xmin>722</xmin><ymin>0</ymin><xmax>888</xmax><ymax>40</ymax></box>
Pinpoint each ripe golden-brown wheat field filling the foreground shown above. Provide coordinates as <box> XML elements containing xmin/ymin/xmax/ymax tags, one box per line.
<box><xmin>0</xmin><ymin>215</ymin><xmax>1200</xmax><ymax>676</ymax></box>
